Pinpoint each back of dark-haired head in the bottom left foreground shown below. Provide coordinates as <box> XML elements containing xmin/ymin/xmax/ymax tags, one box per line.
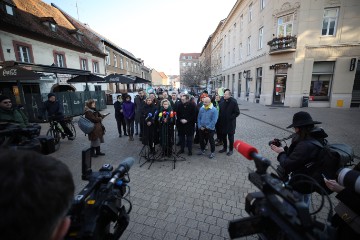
<box><xmin>0</xmin><ymin>149</ymin><xmax>74</xmax><ymax>240</ymax></box>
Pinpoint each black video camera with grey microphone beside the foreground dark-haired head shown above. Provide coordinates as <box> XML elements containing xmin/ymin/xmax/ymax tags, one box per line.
<box><xmin>65</xmin><ymin>148</ymin><xmax>134</xmax><ymax>240</ymax></box>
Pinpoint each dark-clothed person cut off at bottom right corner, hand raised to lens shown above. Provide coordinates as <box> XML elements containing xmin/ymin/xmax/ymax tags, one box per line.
<box><xmin>324</xmin><ymin>170</ymin><xmax>360</xmax><ymax>239</ymax></box>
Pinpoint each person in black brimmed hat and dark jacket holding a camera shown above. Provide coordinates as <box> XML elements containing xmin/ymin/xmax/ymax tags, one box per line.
<box><xmin>270</xmin><ymin>112</ymin><xmax>328</xmax><ymax>201</ymax></box>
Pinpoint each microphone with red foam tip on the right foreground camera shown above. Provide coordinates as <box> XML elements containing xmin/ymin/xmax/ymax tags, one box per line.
<box><xmin>234</xmin><ymin>140</ymin><xmax>271</xmax><ymax>174</ymax></box>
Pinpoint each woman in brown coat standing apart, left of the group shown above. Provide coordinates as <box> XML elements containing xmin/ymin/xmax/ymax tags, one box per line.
<box><xmin>84</xmin><ymin>99</ymin><xmax>106</xmax><ymax>157</ymax></box>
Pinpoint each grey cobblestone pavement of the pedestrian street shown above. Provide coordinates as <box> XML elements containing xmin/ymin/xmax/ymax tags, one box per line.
<box><xmin>42</xmin><ymin>101</ymin><xmax>360</xmax><ymax>240</ymax></box>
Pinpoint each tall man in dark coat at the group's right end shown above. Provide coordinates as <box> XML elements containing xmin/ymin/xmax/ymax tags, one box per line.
<box><xmin>218</xmin><ymin>89</ymin><xmax>240</xmax><ymax>156</ymax></box>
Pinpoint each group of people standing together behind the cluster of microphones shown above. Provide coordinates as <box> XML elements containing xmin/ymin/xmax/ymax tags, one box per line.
<box><xmin>114</xmin><ymin>89</ymin><xmax>240</xmax><ymax>158</ymax></box>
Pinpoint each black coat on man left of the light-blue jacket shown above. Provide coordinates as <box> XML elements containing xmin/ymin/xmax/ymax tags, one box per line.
<box><xmin>176</xmin><ymin>102</ymin><xmax>196</xmax><ymax>135</ymax></box>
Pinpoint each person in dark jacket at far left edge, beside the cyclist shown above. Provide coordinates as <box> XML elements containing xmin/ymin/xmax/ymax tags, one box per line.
<box><xmin>0</xmin><ymin>95</ymin><xmax>29</xmax><ymax>128</ymax></box>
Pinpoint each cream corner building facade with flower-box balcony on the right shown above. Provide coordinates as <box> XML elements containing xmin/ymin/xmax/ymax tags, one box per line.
<box><xmin>208</xmin><ymin>0</ymin><xmax>360</xmax><ymax>108</ymax></box>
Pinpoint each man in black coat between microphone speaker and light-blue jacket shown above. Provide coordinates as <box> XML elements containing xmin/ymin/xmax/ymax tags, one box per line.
<box><xmin>176</xmin><ymin>94</ymin><xmax>196</xmax><ymax>156</ymax></box>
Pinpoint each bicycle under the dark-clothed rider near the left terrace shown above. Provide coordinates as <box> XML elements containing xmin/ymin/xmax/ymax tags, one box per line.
<box><xmin>46</xmin><ymin>117</ymin><xmax>76</xmax><ymax>151</ymax></box>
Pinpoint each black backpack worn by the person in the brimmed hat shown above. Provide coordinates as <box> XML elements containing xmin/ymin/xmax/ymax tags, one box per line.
<box><xmin>289</xmin><ymin>139</ymin><xmax>354</xmax><ymax>194</ymax></box>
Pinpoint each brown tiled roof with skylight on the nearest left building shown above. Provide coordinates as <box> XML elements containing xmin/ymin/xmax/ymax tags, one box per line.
<box><xmin>0</xmin><ymin>0</ymin><xmax>104</xmax><ymax>57</ymax></box>
